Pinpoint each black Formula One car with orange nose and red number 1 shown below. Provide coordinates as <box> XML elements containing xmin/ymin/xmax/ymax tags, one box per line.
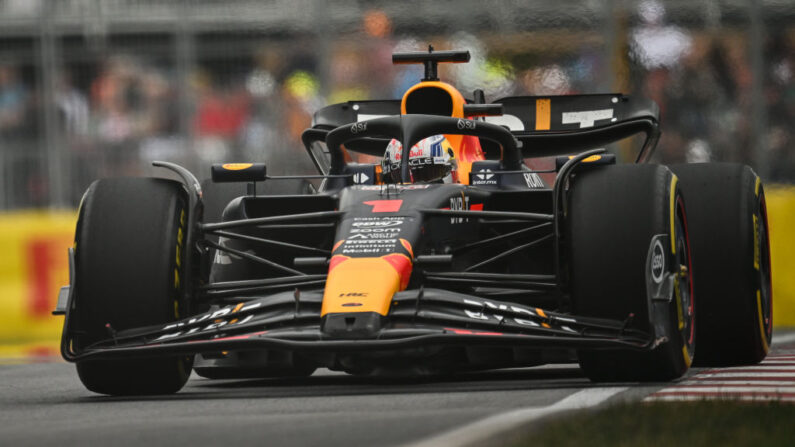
<box><xmin>55</xmin><ymin>48</ymin><xmax>772</xmax><ymax>395</ymax></box>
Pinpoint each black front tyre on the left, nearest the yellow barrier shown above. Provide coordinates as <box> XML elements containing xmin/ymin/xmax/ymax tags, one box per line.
<box><xmin>75</xmin><ymin>178</ymin><xmax>193</xmax><ymax>395</ymax></box>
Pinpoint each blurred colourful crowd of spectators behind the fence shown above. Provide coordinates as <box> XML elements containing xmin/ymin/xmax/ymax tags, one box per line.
<box><xmin>0</xmin><ymin>2</ymin><xmax>795</xmax><ymax>209</ymax></box>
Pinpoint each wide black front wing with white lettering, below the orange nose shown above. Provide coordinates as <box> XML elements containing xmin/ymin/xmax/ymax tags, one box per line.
<box><xmin>61</xmin><ymin>289</ymin><xmax>666</xmax><ymax>361</ymax></box>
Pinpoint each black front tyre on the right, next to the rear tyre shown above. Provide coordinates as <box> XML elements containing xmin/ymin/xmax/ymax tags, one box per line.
<box><xmin>566</xmin><ymin>165</ymin><xmax>695</xmax><ymax>382</ymax></box>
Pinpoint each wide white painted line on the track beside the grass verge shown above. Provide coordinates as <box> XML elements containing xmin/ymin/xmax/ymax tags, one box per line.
<box><xmin>408</xmin><ymin>387</ymin><xmax>628</xmax><ymax>447</ymax></box>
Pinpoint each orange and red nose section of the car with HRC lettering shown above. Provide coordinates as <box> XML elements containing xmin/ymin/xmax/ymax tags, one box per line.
<box><xmin>320</xmin><ymin>254</ymin><xmax>412</xmax><ymax>317</ymax></box>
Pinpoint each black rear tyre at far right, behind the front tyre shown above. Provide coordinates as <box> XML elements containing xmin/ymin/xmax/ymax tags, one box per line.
<box><xmin>671</xmin><ymin>163</ymin><xmax>773</xmax><ymax>366</ymax></box>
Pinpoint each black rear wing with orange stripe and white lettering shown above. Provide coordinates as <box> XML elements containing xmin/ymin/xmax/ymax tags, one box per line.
<box><xmin>302</xmin><ymin>94</ymin><xmax>660</xmax><ymax>173</ymax></box>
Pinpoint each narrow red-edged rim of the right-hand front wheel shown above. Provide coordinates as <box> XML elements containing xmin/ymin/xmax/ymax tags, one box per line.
<box><xmin>674</xmin><ymin>196</ymin><xmax>696</xmax><ymax>362</ymax></box>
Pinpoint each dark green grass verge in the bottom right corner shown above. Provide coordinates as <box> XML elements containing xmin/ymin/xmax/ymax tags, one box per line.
<box><xmin>507</xmin><ymin>400</ymin><xmax>795</xmax><ymax>447</ymax></box>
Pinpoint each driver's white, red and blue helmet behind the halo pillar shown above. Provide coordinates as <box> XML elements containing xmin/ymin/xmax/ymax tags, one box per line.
<box><xmin>381</xmin><ymin>135</ymin><xmax>455</xmax><ymax>183</ymax></box>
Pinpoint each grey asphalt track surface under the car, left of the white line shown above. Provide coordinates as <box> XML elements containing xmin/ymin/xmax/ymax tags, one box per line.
<box><xmin>0</xmin><ymin>334</ymin><xmax>792</xmax><ymax>447</ymax></box>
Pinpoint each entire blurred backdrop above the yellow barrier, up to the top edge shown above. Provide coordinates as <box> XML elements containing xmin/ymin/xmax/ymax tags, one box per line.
<box><xmin>0</xmin><ymin>0</ymin><xmax>795</xmax><ymax>211</ymax></box>
